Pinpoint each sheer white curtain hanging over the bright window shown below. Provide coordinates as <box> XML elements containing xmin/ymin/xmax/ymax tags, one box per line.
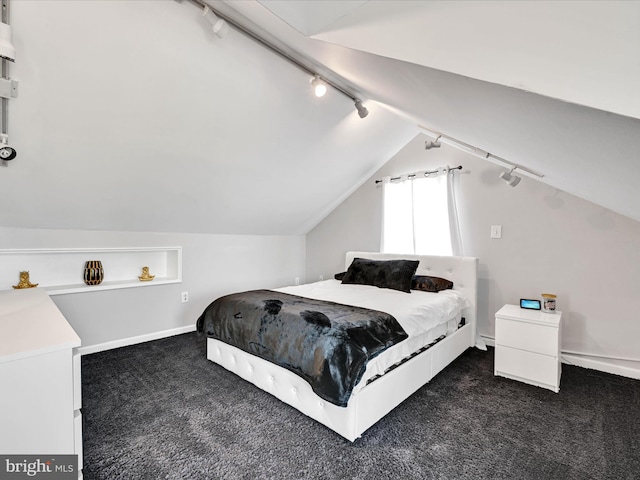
<box><xmin>382</xmin><ymin>167</ymin><xmax>462</xmax><ymax>255</ymax></box>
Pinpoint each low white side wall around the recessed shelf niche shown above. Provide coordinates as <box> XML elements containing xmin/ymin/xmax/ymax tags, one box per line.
<box><xmin>0</xmin><ymin>228</ymin><xmax>305</xmax><ymax>348</ymax></box>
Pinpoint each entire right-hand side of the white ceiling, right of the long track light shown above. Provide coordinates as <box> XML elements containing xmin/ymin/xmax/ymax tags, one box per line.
<box><xmin>221</xmin><ymin>0</ymin><xmax>640</xmax><ymax>220</ymax></box>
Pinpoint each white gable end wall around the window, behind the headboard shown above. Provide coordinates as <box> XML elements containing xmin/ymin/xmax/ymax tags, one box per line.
<box><xmin>307</xmin><ymin>135</ymin><xmax>640</xmax><ymax>371</ymax></box>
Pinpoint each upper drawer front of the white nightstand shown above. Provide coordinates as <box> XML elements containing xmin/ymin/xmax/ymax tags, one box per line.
<box><xmin>496</xmin><ymin>317</ymin><xmax>558</xmax><ymax>357</ymax></box>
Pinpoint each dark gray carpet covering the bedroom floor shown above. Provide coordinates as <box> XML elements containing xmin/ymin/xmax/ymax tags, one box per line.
<box><xmin>82</xmin><ymin>333</ymin><xmax>640</xmax><ymax>480</ymax></box>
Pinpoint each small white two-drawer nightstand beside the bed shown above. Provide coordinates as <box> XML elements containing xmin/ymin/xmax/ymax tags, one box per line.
<box><xmin>493</xmin><ymin>305</ymin><xmax>562</xmax><ymax>393</ymax></box>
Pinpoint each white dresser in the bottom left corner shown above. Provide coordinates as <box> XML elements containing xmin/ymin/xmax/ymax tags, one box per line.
<box><xmin>0</xmin><ymin>288</ymin><xmax>82</xmax><ymax>477</ymax></box>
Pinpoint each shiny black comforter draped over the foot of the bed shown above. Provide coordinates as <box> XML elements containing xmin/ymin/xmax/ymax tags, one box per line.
<box><xmin>197</xmin><ymin>290</ymin><xmax>407</xmax><ymax>407</ymax></box>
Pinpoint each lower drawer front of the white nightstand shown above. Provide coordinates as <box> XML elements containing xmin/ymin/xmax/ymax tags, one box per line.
<box><xmin>495</xmin><ymin>347</ymin><xmax>560</xmax><ymax>392</ymax></box>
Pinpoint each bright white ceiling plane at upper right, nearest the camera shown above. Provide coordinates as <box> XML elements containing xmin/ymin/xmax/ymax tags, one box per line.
<box><xmin>260</xmin><ymin>0</ymin><xmax>640</xmax><ymax>118</ymax></box>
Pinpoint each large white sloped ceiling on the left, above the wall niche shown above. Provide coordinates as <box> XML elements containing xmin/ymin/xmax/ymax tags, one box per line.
<box><xmin>0</xmin><ymin>0</ymin><xmax>415</xmax><ymax>235</ymax></box>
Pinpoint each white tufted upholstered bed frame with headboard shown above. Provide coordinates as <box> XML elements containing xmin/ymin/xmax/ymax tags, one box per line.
<box><xmin>207</xmin><ymin>252</ymin><xmax>478</xmax><ymax>442</ymax></box>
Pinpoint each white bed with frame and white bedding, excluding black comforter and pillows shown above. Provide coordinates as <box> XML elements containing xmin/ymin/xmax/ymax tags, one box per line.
<box><xmin>198</xmin><ymin>252</ymin><xmax>477</xmax><ymax>442</ymax></box>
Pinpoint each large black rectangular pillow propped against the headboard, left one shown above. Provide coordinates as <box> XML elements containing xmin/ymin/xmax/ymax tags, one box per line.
<box><xmin>342</xmin><ymin>258</ymin><xmax>420</xmax><ymax>293</ymax></box>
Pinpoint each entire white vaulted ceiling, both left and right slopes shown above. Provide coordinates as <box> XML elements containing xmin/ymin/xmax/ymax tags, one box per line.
<box><xmin>0</xmin><ymin>0</ymin><xmax>640</xmax><ymax>234</ymax></box>
